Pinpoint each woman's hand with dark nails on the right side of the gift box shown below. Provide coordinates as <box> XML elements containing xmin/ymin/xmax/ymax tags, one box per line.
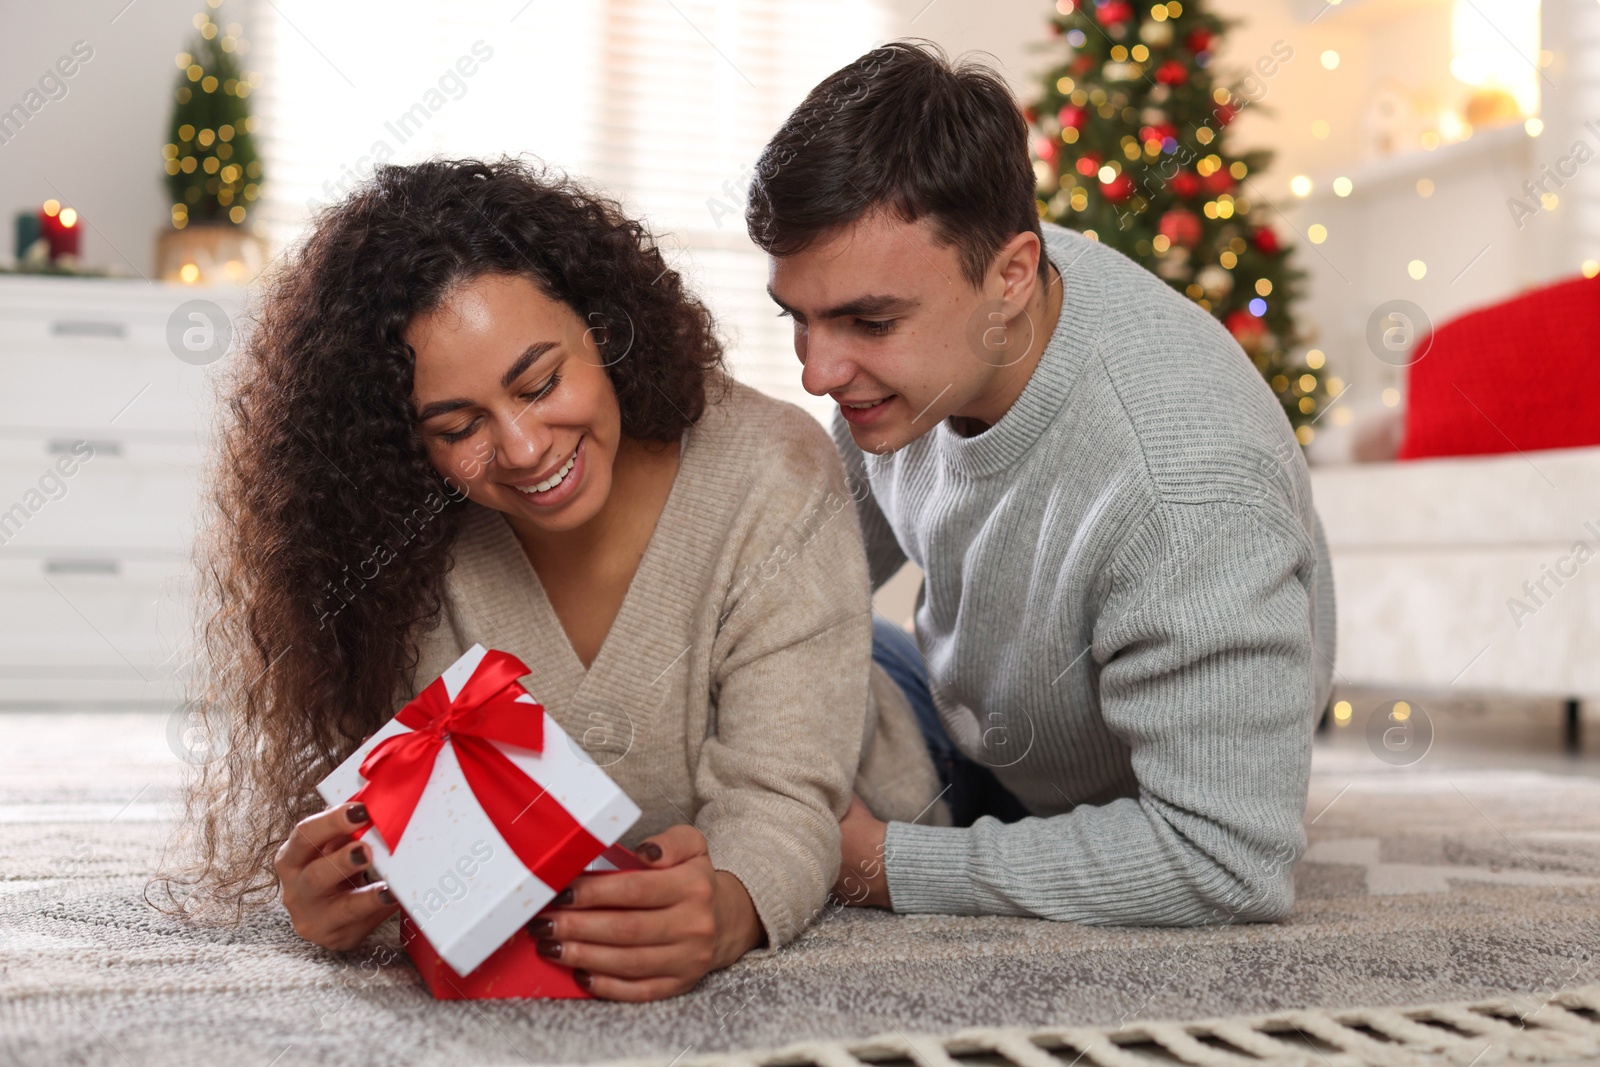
<box><xmin>528</xmin><ymin>825</ymin><xmax>765</xmax><ymax>1000</ymax></box>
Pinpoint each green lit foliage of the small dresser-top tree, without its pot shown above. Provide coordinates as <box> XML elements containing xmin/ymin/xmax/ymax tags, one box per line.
<box><xmin>162</xmin><ymin>0</ymin><xmax>261</xmax><ymax>229</ymax></box>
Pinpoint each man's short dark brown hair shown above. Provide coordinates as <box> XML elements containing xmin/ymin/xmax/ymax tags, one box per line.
<box><xmin>744</xmin><ymin>40</ymin><xmax>1045</xmax><ymax>286</ymax></box>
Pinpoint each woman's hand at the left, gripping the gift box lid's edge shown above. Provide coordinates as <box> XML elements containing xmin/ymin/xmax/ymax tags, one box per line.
<box><xmin>272</xmin><ymin>805</ymin><xmax>400</xmax><ymax>952</ymax></box>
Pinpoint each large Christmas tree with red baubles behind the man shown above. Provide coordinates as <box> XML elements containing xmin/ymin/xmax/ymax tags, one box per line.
<box><xmin>1027</xmin><ymin>0</ymin><xmax>1328</xmax><ymax>445</ymax></box>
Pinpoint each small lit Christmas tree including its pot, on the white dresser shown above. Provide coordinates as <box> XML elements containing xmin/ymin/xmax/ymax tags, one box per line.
<box><xmin>157</xmin><ymin>0</ymin><xmax>266</xmax><ymax>283</ymax></box>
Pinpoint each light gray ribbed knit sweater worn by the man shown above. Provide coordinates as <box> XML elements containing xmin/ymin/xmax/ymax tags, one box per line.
<box><xmin>834</xmin><ymin>226</ymin><xmax>1334</xmax><ymax>925</ymax></box>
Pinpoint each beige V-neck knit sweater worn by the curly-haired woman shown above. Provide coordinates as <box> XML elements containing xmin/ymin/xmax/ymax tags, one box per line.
<box><xmin>411</xmin><ymin>382</ymin><xmax>947</xmax><ymax>947</ymax></box>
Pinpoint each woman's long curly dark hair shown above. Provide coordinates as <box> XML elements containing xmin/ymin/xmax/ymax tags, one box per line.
<box><xmin>147</xmin><ymin>158</ymin><xmax>725</xmax><ymax>921</ymax></box>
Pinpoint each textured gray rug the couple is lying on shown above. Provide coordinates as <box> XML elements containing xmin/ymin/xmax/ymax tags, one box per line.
<box><xmin>0</xmin><ymin>713</ymin><xmax>1600</xmax><ymax>1067</ymax></box>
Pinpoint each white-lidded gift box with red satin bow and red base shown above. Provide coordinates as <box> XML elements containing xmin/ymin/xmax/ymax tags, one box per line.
<box><xmin>317</xmin><ymin>645</ymin><xmax>640</xmax><ymax>998</ymax></box>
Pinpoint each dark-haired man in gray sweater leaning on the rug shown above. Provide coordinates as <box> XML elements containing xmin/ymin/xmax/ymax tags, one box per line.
<box><xmin>747</xmin><ymin>42</ymin><xmax>1333</xmax><ymax>925</ymax></box>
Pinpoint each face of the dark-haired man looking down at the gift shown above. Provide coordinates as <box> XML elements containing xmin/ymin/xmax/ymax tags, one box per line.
<box><xmin>766</xmin><ymin>211</ymin><xmax>1016</xmax><ymax>454</ymax></box>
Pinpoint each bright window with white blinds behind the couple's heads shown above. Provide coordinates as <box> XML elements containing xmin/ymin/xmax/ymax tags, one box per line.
<box><xmin>243</xmin><ymin>0</ymin><xmax>886</xmax><ymax>418</ymax></box>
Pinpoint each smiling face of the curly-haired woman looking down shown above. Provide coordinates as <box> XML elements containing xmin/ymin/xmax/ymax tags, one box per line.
<box><xmin>405</xmin><ymin>274</ymin><xmax>622</xmax><ymax>533</ymax></box>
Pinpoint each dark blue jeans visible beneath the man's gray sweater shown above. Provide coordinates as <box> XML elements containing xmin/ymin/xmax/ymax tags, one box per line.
<box><xmin>872</xmin><ymin>614</ymin><xmax>1027</xmax><ymax>825</ymax></box>
